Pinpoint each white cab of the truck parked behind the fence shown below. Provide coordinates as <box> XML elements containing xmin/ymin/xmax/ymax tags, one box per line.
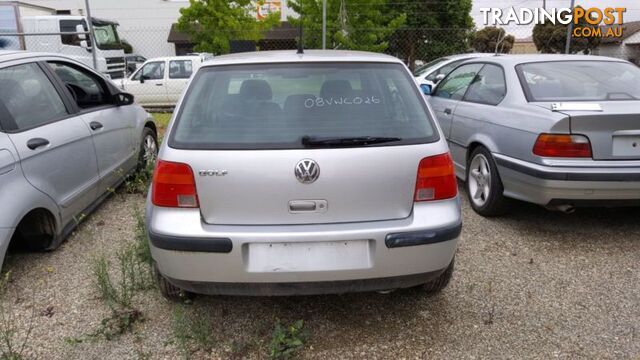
<box><xmin>21</xmin><ymin>15</ymin><xmax>125</xmax><ymax>79</ymax></box>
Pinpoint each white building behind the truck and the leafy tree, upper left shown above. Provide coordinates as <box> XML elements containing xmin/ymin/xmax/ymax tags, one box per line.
<box><xmin>11</xmin><ymin>0</ymin><xmax>292</xmax><ymax>58</ymax></box>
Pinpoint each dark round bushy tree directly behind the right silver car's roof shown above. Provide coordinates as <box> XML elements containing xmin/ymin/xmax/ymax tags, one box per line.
<box><xmin>533</xmin><ymin>6</ymin><xmax>600</xmax><ymax>54</ymax></box>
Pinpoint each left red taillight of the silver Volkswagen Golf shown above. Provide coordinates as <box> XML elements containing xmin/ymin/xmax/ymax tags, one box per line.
<box><xmin>151</xmin><ymin>160</ymin><xmax>198</xmax><ymax>208</ymax></box>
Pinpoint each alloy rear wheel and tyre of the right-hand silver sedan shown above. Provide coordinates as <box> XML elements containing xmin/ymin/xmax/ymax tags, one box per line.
<box><xmin>465</xmin><ymin>146</ymin><xmax>509</xmax><ymax>217</ymax></box>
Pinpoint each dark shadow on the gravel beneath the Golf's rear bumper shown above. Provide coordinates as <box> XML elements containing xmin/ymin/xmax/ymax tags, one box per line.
<box><xmin>193</xmin><ymin>289</ymin><xmax>456</xmax><ymax>351</ymax></box>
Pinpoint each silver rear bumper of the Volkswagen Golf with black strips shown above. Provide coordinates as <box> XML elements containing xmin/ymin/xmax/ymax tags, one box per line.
<box><xmin>147</xmin><ymin>199</ymin><xmax>461</xmax><ymax>295</ymax></box>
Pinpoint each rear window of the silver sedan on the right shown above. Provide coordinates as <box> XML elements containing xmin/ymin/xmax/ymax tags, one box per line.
<box><xmin>516</xmin><ymin>60</ymin><xmax>640</xmax><ymax>101</ymax></box>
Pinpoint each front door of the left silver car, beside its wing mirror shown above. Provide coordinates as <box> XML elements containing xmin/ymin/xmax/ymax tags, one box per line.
<box><xmin>48</xmin><ymin>61</ymin><xmax>138</xmax><ymax>194</ymax></box>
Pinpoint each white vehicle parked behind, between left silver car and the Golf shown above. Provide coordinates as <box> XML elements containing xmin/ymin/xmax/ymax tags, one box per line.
<box><xmin>122</xmin><ymin>56</ymin><xmax>203</xmax><ymax>107</ymax></box>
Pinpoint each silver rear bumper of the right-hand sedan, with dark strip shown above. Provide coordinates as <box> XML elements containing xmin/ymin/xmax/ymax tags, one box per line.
<box><xmin>494</xmin><ymin>154</ymin><xmax>640</xmax><ymax>205</ymax></box>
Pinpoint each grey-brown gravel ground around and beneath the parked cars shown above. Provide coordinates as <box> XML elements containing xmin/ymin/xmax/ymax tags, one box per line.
<box><xmin>2</xmin><ymin>190</ymin><xmax>640</xmax><ymax>359</ymax></box>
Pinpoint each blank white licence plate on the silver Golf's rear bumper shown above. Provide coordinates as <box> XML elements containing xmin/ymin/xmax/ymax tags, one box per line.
<box><xmin>247</xmin><ymin>240</ymin><xmax>372</xmax><ymax>272</ymax></box>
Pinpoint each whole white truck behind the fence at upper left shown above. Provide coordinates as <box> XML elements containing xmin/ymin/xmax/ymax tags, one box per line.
<box><xmin>0</xmin><ymin>1</ymin><xmax>126</xmax><ymax>79</ymax></box>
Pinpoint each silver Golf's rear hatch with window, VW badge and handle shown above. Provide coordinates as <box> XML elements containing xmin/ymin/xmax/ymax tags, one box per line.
<box><xmin>162</xmin><ymin>63</ymin><xmax>446</xmax><ymax>225</ymax></box>
